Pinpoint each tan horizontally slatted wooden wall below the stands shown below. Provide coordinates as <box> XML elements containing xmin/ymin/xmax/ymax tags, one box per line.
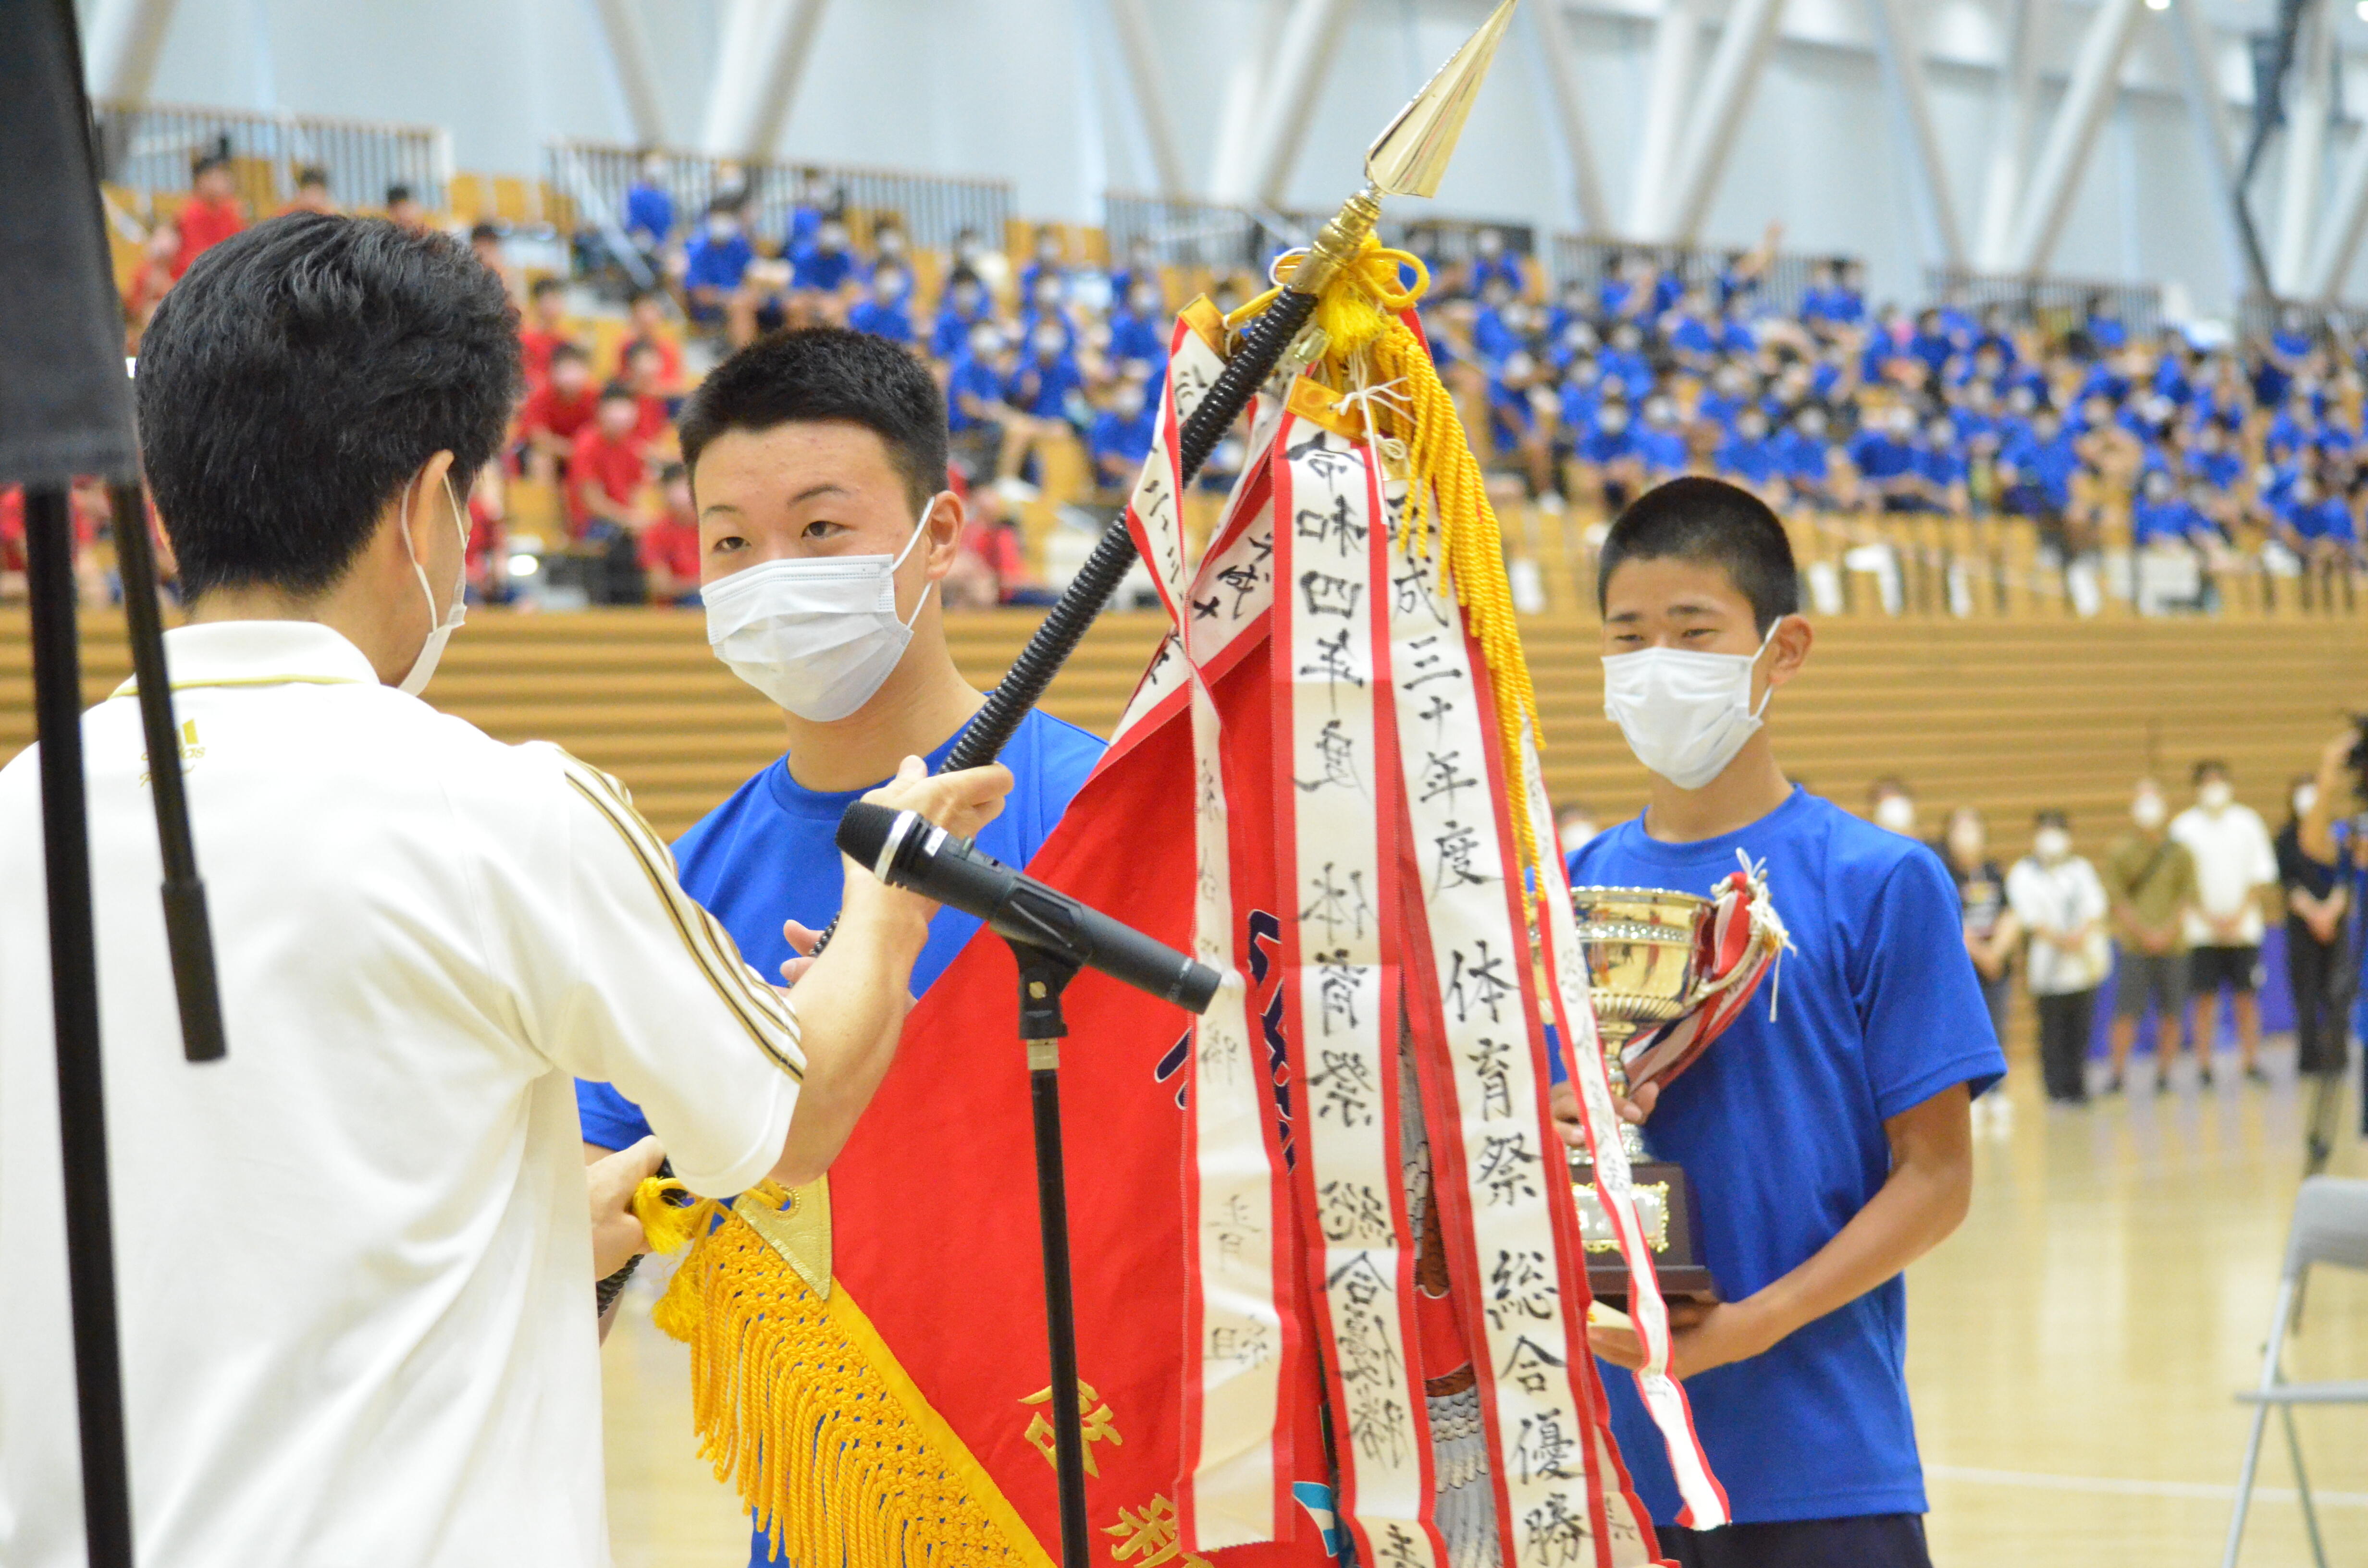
<box><xmin>13</xmin><ymin>609</ymin><xmax>2368</xmax><ymax>855</ymax></box>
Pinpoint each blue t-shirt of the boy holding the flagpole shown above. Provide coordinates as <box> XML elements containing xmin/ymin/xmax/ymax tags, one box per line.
<box><xmin>576</xmin><ymin>710</ymin><xmax>1101</xmax><ymax>1149</ymax></box>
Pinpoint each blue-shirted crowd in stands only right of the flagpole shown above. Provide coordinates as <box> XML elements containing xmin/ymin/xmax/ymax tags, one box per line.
<box><xmin>1426</xmin><ymin>239</ymin><xmax>2368</xmax><ymax>589</ymax></box>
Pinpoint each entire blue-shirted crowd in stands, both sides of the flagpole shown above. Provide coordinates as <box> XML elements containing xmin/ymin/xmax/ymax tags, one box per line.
<box><xmin>623</xmin><ymin>168</ymin><xmax>2368</xmax><ymax>589</ymax></box>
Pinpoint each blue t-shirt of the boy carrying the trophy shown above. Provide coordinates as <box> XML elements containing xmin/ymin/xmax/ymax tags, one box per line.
<box><xmin>1572</xmin><ymin>789</ymin><xmax>2006</xmax><ymax>1523</ymax></box>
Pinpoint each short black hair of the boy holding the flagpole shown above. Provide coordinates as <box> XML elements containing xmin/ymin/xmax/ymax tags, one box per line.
<box><xmin>682</xmin><ymin>327</ymin><xmax>945</xmax><ymax>507</ymax></box>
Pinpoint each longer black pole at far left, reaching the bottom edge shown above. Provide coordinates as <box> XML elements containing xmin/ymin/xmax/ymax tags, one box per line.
<box><xmin>24</xmin><ymin>486</ymin><xmax>136</xmax><ymax>1568</ymax></box>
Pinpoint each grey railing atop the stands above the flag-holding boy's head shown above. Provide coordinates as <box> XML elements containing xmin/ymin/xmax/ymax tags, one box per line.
<box><xmin>543</xmin><ymin>142</ymin><xmax>1013</xmax><ymax>251</ymax></box>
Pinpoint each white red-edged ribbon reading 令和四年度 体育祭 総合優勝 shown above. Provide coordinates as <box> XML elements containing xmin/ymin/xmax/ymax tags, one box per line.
<box><xmin>1271</xmin><ymin>415</ymin><xmax>1442</xmax><ymax>1568</ymax></box>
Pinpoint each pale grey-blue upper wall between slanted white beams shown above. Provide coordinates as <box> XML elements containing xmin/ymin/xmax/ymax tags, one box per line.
<box><xmin>83</xmin><ymin>0</ymin><xmax>2368</xmax><ymax>313</ymax></box>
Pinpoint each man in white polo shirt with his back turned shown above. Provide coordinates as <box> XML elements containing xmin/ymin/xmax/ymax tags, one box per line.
<box><xmin>0</xmin><ymin>213</ymin><xmax>1009</xmax><ymax>1568</ymax></box>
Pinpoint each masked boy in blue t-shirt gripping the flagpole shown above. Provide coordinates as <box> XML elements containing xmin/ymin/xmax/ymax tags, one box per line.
<box><xmin>576</xmin><ymin>327</ymin><xmax>1101</xmax><ymax>1411</ymax></box>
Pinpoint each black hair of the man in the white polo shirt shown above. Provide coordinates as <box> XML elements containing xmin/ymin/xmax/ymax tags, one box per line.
<box><xmin>133</xmin><ymin>213</ymin><xmax>518</xmax><ymax>597</ymax></box>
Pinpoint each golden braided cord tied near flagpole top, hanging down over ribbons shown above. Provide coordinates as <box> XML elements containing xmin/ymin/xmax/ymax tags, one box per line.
<box><xmin>1224</xmin><ymin>234</ymin><xmax>1539</xmax><ymax>888</ymax></box>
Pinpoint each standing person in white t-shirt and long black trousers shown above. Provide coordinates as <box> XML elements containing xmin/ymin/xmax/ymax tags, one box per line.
<box><xmin>2006</xmin><ymin>810</ymin><xmax>2112</xmax><ymax>1106</ymax></box>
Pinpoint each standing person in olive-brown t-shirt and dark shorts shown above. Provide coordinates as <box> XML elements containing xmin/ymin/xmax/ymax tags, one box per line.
<box><xmin>2098</xmin><ymin>779</ymin><xmax>2212</xmax><ymax>1094</ymax></box>
